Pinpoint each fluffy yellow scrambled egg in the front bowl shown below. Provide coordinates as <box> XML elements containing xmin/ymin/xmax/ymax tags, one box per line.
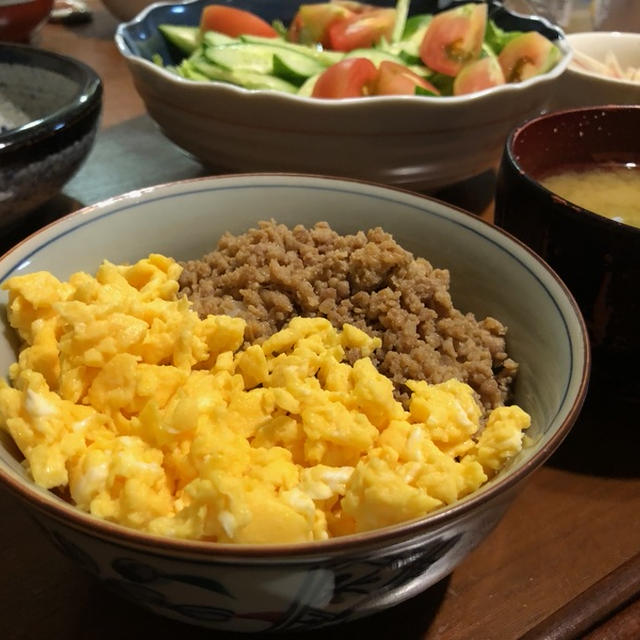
<box><xmin>0</xmin><ymin>254</ymin><xmax>530</xmax><ymax>543</ymax></box>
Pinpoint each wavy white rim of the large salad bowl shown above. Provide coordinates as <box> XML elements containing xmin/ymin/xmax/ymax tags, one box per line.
<box><xmin>114</xmin><ymin>0</ymin><xmax>573</xmax><ymax>110</ymax></box>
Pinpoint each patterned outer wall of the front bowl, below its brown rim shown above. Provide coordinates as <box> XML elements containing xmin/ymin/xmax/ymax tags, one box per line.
<box><xmin>39</xmin><ymin>521</ymin><xmax>475</xmax><ymax>632</ymax></box>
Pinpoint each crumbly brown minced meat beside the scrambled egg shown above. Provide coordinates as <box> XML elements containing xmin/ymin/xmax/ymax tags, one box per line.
<box><xmin>180</xmin><ymin>221</ymin><xmax>517</xmax><ymax>409</ymax></box>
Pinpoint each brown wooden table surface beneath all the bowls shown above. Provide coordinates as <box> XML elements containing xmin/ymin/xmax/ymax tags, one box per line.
<box><xmin>0</xmin><ymin>0</ymin><xmax>640</xmax><ymax>640</ymax></box>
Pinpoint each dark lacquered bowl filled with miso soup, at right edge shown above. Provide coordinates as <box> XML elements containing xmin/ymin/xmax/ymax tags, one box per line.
<box><xmin>495</xmin><ymin>105</ymin><xmax>640</xmax><ymax>399</ymax></box>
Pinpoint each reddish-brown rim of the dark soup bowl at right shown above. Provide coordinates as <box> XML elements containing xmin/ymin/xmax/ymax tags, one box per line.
<box><xmin>505</xmin><ymin>104</ymin><xmax>640</xmax><ymax>239</ymax></box>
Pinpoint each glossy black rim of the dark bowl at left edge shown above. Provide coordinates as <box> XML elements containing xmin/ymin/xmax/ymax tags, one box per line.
<box><xmin>0</xmin><ymin>42</ymin><xmax>103</xmax><ymax>154</ymax></box>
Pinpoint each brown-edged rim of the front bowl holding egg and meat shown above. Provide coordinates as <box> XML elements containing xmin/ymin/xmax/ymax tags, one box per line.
<box><xmin>0</xmin><ymin>172</ymin><xmax>591</xmax><ymax>563</ymax></box>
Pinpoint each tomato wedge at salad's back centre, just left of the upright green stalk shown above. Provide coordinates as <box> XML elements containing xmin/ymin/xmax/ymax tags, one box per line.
<box><xmin>327</xmin><ymin>9</ymin><xmax>396</xmax><ymax>51</ymax></box>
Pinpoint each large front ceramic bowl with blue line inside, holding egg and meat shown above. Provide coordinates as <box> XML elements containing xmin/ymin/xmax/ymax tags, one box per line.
<box><xmin>0</xmin><ymin>174</ymin><xmax>590</xmax><ymax>632</ymax></box>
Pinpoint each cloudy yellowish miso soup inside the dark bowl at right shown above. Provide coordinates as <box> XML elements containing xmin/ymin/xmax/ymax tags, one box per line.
<box><xmin>540</xmin><ymin>163</ymin><xmax>640</xmax><ymax>228</ymax></box>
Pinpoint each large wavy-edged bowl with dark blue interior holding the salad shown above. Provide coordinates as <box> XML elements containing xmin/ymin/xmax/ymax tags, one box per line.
<box><xmin>116</xmin><ymin>0</ymin><xmax>570</xmax><ymax>190</ymax></box>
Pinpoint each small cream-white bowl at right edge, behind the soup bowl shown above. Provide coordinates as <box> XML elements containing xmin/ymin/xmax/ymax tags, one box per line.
<box><xmin>554</xmin><ymin>31</ymin><xmax>640</xmax><ymax>109</ymax></box>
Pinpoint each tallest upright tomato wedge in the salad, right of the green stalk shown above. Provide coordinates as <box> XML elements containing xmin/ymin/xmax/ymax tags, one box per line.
<box><xmin>420</xmin><ymin>3</ymin><xmax>487</xmax><ymax>76</ymax></box>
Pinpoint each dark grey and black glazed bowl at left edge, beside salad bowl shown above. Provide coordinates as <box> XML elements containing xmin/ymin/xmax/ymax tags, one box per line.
<box><xmin>0</xmin><ymin>43</ymin><xmax>102</xmax><ymax>229</ymax></box>
